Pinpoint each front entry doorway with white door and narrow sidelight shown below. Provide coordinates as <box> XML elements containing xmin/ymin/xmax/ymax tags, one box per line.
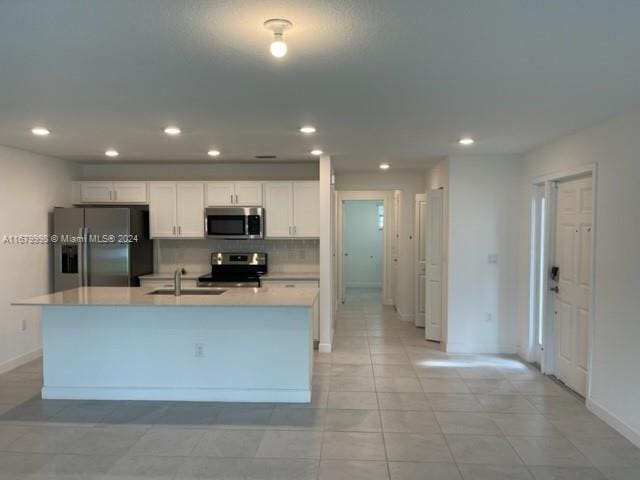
<box><xmin>530</xmin><ymin>167</ymin><xmax>595</xmax><ymax>397</ymax></box>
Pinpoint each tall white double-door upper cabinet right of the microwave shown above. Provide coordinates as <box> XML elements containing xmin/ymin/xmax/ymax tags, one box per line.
<box><xmin>264</xmin><ymin>181</ymin><xmax>320</xmax><ymax>238</ymax></box>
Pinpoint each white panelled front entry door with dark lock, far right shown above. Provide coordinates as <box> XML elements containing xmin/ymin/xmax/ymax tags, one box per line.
<box><xmin>551</xmin><ymin>177</ymin><xmax>593</xmax><ymax>396</ymax></box>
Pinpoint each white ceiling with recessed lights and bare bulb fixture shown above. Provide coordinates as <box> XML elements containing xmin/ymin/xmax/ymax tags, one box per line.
<box><xmin>0</xmin><ymin>0</ymin><xmax>640</xmax><ymax>170</ymax></box>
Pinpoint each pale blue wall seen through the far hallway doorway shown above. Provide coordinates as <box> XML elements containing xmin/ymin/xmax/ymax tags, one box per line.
<box><xmin>343</xmin><ymin>200</ymin><xmax>386</xmax><ymax>288</ymax></box>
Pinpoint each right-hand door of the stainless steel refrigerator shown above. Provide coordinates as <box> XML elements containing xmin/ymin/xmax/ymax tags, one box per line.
<box><xmin>84</xmin><ymin>208</ymin><xmax>130</xmax><ymax>287</ymax></box>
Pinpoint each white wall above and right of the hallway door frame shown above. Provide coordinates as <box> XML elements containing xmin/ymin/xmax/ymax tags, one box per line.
<box><xmin>336</xmin><ymin>171</ymin><xmax>425</xmax><ymax>321</ymax></box>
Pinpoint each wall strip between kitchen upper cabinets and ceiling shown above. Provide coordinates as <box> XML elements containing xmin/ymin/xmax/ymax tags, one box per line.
<box><xmin>80</xmin><ymin>161</ymin><xmax>318</xmax><ymax>180</ymax></box>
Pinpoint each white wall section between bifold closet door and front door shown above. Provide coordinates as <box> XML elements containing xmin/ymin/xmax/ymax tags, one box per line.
<box><xmin>447</xmin><ymin>156</ymin><xmax>522</xmax><ymax>353</ymax></box>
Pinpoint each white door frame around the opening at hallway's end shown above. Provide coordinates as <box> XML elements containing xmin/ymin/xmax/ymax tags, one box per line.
<box><xmin>336</xmin><ymin>190</ymin><xmax>395</xmax><ymax>305</ymax></box>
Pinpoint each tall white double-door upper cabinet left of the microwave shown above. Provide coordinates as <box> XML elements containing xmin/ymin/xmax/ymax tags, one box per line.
<box><xmin>149</xmin><ymin>182</ymin><xmax>204</xmax><ymax>238</ymax></box>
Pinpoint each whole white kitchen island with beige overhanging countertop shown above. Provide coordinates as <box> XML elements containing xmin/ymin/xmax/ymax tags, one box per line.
<box><xmin>14</xmin><ymin>287</ymin><xmax>318</xmax><ymax>403</ymax></box>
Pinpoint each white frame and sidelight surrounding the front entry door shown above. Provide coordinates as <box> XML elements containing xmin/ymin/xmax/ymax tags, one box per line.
<box><xmin>528</xmin><ymin>164</ymin><xmax>598</xmax><ymax>399</ymax></box>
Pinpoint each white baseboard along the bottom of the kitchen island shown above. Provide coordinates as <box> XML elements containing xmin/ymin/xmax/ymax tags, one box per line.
<box><xmin>42</xmin><ymin>386</ymin><xmax>311</xmax><ymax>403</ymax></box>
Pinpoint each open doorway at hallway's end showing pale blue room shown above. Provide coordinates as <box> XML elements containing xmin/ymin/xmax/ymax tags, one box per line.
<box><xmin>343</xmin><ymin>200</ymin><xmax>385</xmax><ymax>303</ymax></box>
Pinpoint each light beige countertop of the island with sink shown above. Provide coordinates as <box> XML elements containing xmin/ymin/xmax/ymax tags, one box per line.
<box><xmin>12</xmin><ymin>287</ymin><xmax>319</xmax><ymax>307</ymax></box>
